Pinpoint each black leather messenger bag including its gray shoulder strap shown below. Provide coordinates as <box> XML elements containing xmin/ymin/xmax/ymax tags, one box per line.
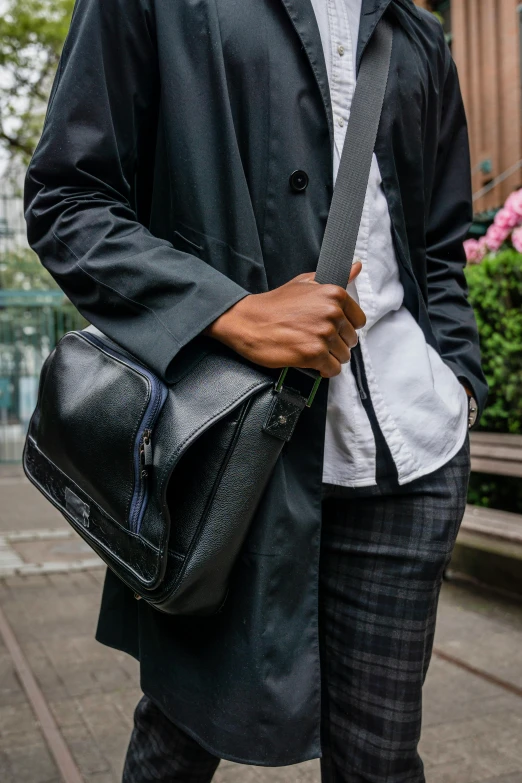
<box><xmin>24</xmin><ymin>20</ymin><xmax>392</xmax><ymax>614</ymax></box>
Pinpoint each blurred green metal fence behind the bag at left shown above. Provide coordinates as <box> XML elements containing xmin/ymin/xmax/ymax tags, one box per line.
<box><xmin>0</xmin><ymin>187</ymin><xmax>85</xmax><ymax>463</ymax></box>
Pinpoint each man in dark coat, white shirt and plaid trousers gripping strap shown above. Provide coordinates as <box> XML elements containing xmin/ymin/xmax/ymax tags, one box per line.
<box><xmin>26</xmin><ymin>0</ymin><xmax>486</xmax><ymax>783</ymax></box>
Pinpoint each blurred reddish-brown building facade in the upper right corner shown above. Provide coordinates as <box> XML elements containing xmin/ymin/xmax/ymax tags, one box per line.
<box><xmin>419</xmin><ymin>0</ymin><xmax>522</xmax><ymax>212</ymax></box>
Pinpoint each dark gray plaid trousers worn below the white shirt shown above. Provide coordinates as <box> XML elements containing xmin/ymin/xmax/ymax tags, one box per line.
<box><xmin>123</xmin><ymin>430</ymin><xmax>470</xmax><ymax>783</ymax></box>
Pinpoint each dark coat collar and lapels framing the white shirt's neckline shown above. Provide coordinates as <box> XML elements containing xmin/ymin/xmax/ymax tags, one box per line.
<box><xmin>281</xmin><ymin>0</ymin><xmax>419</xmax><ymax>150</ymax></box>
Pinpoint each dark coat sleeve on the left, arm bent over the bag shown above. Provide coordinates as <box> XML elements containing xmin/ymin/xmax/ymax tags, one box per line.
<box><xmin>25</xmin><ymin>0</ymin><xmax>248</xmax><ymax>379</ymax></box>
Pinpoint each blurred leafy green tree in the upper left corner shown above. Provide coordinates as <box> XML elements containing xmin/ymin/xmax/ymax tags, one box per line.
<box><xmin>0</xmin><ymin>0</ymin><xmax>74</xmax><ymax>164</ymax></box>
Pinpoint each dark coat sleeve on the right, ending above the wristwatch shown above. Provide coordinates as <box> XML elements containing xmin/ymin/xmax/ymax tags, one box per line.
<box><xmin>426</xmin><ymin>48</ymin><xmax>488</xmax><ymax>420</ymax></box>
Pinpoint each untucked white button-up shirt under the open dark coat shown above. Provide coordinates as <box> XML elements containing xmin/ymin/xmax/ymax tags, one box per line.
<box><xmin>312</xmin><ymin>0</ymin><xmax>468</xmax><ymax>487</ymax></box>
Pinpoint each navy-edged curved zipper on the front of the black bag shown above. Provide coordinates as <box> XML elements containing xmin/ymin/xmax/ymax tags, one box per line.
<box><xmin>82</xmin><ymin>332</ymin><xmax>167</xmax><ymax>533</ymax></box>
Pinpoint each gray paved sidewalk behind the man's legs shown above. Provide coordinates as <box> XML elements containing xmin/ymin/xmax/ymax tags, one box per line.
<box><xmin>0</xmin><ymin>469</ymin><xmax>522</xmax><ymax>783</ymax></box>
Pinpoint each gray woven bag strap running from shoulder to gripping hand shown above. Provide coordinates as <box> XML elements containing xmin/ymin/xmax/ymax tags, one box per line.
<box><xmin>315</xmin><ymin>19</ymin><xmax>393</xmax><ymax>288</ymax></box>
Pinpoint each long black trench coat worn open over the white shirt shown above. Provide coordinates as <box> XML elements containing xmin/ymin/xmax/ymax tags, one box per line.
<box><xmin>26</xmin><ymin>0</ymin><xmax>486</xmax><ymax>765</ymax></box>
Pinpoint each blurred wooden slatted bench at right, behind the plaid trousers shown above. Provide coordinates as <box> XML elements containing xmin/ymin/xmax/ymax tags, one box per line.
<box><xmin>450</xmin><ymin>432</ymin><xmax>522</xmax><ymax>595</ymax></box>
